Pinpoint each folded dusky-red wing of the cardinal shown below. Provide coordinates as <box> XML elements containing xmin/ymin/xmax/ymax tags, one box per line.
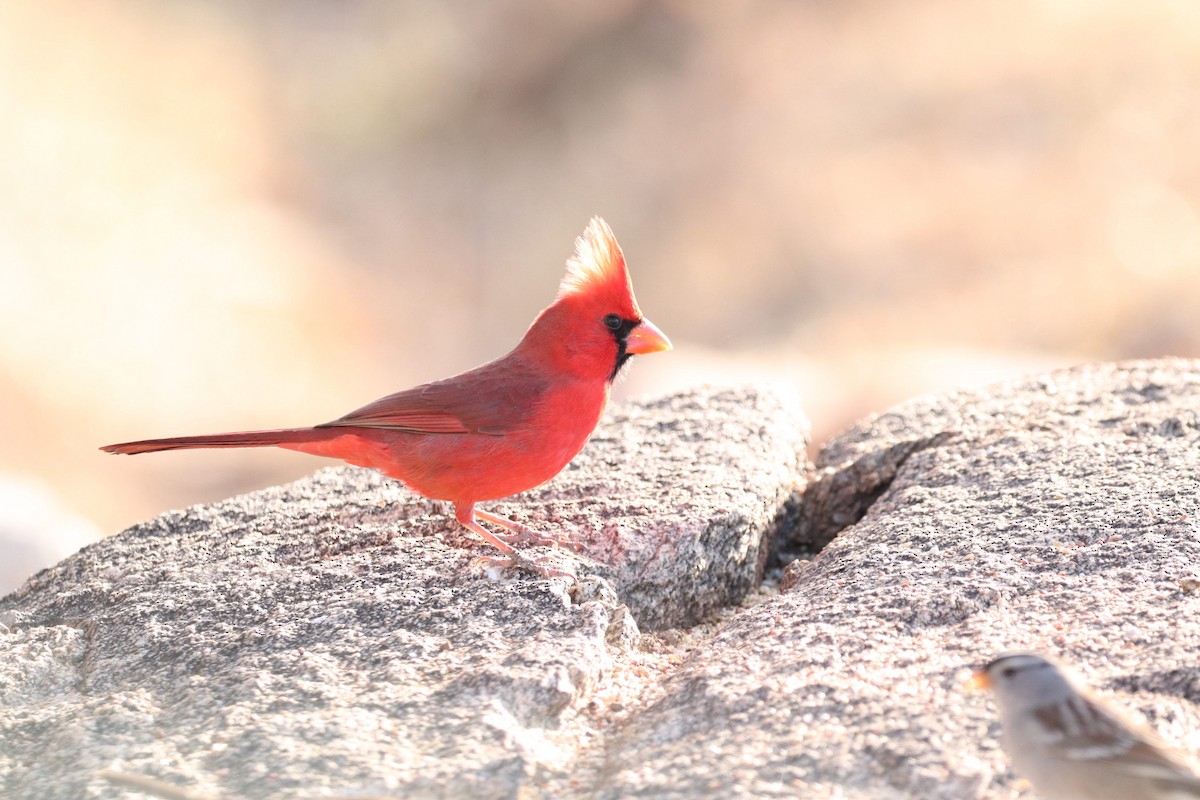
<box><xmin>318</xmin><ymin>354</ymin><xmax>545</xmax><ymax>437</ymax></box>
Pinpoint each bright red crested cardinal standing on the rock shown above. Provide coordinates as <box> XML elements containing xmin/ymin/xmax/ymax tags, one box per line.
<box><xmin>101</xmin><ymin>217</ymin><xmax>671</xmax><ymax>575</ymax></box>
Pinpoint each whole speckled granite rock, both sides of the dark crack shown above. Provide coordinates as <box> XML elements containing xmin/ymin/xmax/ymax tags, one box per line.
<box><xmin>9</xmin><ymin>360</ymin><xmax>1200</xmax><ymax>800</ymax></box>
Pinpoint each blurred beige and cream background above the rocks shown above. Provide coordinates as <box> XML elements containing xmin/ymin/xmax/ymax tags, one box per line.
<box><xmin>0</xmin><ymin>0</ymin><xmax>1200</xmax><ymax>591</ymax></box>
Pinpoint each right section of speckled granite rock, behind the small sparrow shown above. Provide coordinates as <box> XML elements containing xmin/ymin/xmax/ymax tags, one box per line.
<box><xmin>596</xmin><ymin>360</ymin><xmax>1200</xmax><ymax>800</ymax></box>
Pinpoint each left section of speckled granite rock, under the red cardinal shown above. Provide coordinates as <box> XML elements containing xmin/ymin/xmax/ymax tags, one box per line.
<box><xmin>0</xmin><ymin>390</ymin><xmax>805</xmax><ymax>800</ymax></box>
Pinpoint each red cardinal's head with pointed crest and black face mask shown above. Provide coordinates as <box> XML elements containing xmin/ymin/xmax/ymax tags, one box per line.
<box><xmin>526</xmin><ymin>217</ymin><xmax>671</xmax><ymax>381</ymax></box>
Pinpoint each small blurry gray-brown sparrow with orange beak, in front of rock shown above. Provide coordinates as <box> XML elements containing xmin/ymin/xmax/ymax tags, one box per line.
<box><xmin>971</xmin><ymin>652</ymin><xmax>1200</xmax><ymax>800</ymax></box>
